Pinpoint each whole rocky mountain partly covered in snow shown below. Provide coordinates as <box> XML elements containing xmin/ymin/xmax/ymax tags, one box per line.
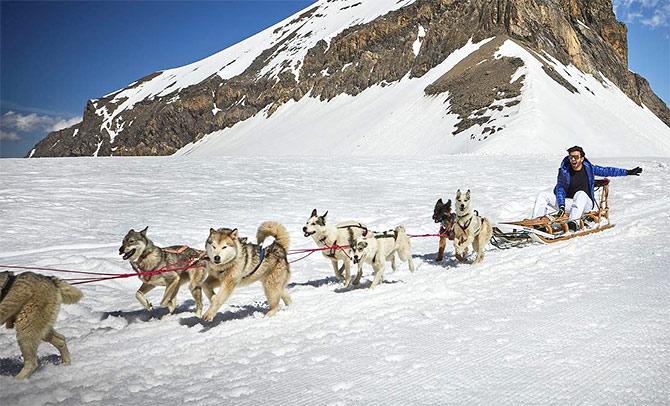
<box><xmin>29</xmin><ymin>0</ymin><xmax>670</xmax><ymax>157</ymax></box>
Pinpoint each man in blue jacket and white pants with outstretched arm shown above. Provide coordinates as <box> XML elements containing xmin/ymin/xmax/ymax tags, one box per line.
<box><xmin>532</xmin><ymin>145</ymin><xmax>642</xmax><ymax>231</ymax></box>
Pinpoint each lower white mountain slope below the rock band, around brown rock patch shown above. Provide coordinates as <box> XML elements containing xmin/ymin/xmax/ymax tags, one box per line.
<box><xmin>177</xmin><ymin>38</ymin><xmax>670</xmax><ymax>157</ymax></box>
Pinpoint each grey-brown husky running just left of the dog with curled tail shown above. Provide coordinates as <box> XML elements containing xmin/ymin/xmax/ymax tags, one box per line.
<box><xmin>119</xmin><ymin>227</ymin><xmax>212</xmax><ymax>317</ymax></box>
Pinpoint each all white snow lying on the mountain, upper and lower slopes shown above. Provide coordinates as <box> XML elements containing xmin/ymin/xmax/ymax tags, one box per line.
<box><xmin>85</xmin><ymin>0</ymin><xmax>670</xmax><ymax>157</ymax></box>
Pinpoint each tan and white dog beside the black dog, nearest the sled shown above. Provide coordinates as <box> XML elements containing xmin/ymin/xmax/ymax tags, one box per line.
<box><xmin>454</xmin><ymin>189</ymin><xmax>493</xmax><ymax>264</ymax></box>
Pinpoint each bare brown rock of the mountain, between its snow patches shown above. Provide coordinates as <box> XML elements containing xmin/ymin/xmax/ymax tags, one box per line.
<box><xmin>33</xmin><ymin>0</ymin><xmax>670</xmax><ymax>157</ymax></box>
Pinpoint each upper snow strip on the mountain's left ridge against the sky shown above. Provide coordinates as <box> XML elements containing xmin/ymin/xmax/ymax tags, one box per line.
<box><xmin>93</xmin><ymin>0</ymin><xmax>416</xmax><ymax>142</ymax></box>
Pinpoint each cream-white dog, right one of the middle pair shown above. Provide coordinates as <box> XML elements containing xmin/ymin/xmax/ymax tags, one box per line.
<box><xmin>352</xmin><ymin>226</ymin><xmax>414</xmax><ymax>288</ymax></box>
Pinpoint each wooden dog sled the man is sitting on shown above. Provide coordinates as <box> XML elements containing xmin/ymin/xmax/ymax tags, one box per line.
<box><xmin>491</xmin><ymin>178</ymin><xmax>614</xmax><ymax>249</ymax></box>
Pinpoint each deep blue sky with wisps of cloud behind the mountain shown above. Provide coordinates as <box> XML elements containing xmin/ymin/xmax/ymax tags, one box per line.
<box><xmin>0</xmin><ymin>0</ymin><xmax>670</xmax><ymax>157</ymax></box>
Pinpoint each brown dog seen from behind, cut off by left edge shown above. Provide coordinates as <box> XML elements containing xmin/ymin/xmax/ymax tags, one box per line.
<box><xmin>0</xmin><ymin>272</ymin><xmax>82</xmax><ymax>379</ymax></box>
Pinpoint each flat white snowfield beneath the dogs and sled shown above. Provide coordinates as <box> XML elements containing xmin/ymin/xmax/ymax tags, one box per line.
<box><xmin>0</xmin><ymin>155</ymin><xmax>670</xmax><ymax>406</ymax></box>
